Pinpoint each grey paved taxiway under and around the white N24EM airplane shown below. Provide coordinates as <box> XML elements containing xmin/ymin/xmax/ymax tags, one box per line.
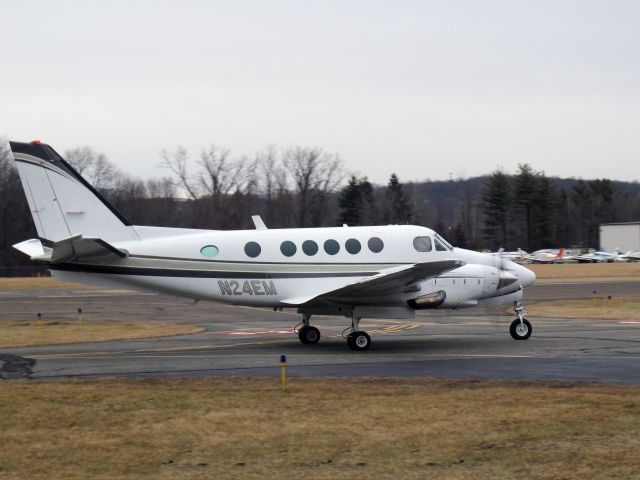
<box><xmin>0</xmin><ymin>282</ymin><xmax>640</xmax><ymax>384</ymax></box>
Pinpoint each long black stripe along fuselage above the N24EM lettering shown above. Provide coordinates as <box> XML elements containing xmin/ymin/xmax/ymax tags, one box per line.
<box><xmin>49</xmin><ymin>263</ymin><xmax>378</xmax><ymax>278</ymax></box>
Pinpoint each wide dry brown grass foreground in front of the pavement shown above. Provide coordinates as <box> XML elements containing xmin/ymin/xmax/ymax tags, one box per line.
<box><xmin>0</xmin><ymin>376</ymin><xmax>640</xmax><ymax>480</ymax></box>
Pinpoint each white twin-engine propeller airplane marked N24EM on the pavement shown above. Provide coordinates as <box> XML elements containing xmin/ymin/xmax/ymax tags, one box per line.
<box><xmin>10</xmin><ymin>141</ymin><xmax>536</xmax><ymax>350</ymax></box>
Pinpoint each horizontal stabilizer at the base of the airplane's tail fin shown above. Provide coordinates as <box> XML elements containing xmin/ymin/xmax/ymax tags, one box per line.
<box><xmin>14</xmin><ymin>235</ymin><xmax>127</xmax><ymax>263</ymax></box>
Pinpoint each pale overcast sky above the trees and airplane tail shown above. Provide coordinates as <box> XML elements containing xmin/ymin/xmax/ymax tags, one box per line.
<box><xmin>0</xmin><ymin>0</ymin><xmax>640</xmax><ymax>183</ymax></box>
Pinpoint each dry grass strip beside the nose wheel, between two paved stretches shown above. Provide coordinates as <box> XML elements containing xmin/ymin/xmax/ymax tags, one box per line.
<box><xmin>527</xmin><ymin>297</ymin><xmax>640</xmax><ymax>321</ymax></box>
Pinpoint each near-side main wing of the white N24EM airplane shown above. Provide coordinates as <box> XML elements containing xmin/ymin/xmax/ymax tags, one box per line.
<box><xmin>282</xmin><ymin>260</ymin><xmax>465</xmax><ymax>305</ymax></box>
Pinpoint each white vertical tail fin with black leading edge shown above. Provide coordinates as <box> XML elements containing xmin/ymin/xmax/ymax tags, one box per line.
<box><xmin>9</xmin><ymin>141</ymin><xmax>137</xmax><ymax>242</ymax></box>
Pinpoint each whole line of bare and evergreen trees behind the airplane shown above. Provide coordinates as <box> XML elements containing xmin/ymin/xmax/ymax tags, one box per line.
<box><xmin>0</xmin><ymin>141</ymin><xmax>640</xmax><ymax>274</ymax></box>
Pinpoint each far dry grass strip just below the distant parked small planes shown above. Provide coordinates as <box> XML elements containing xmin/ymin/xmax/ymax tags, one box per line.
<box><xmin>525</xmin><ymin>262</ymin><xmax>640</xmax><ymax>283</ymax></box>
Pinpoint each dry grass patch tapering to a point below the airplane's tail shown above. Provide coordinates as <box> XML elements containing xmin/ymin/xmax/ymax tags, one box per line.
<box><xmin>0</xmin><ymin>320</ymin><xmax>203</xmax><ymax>347</ymax></box>
